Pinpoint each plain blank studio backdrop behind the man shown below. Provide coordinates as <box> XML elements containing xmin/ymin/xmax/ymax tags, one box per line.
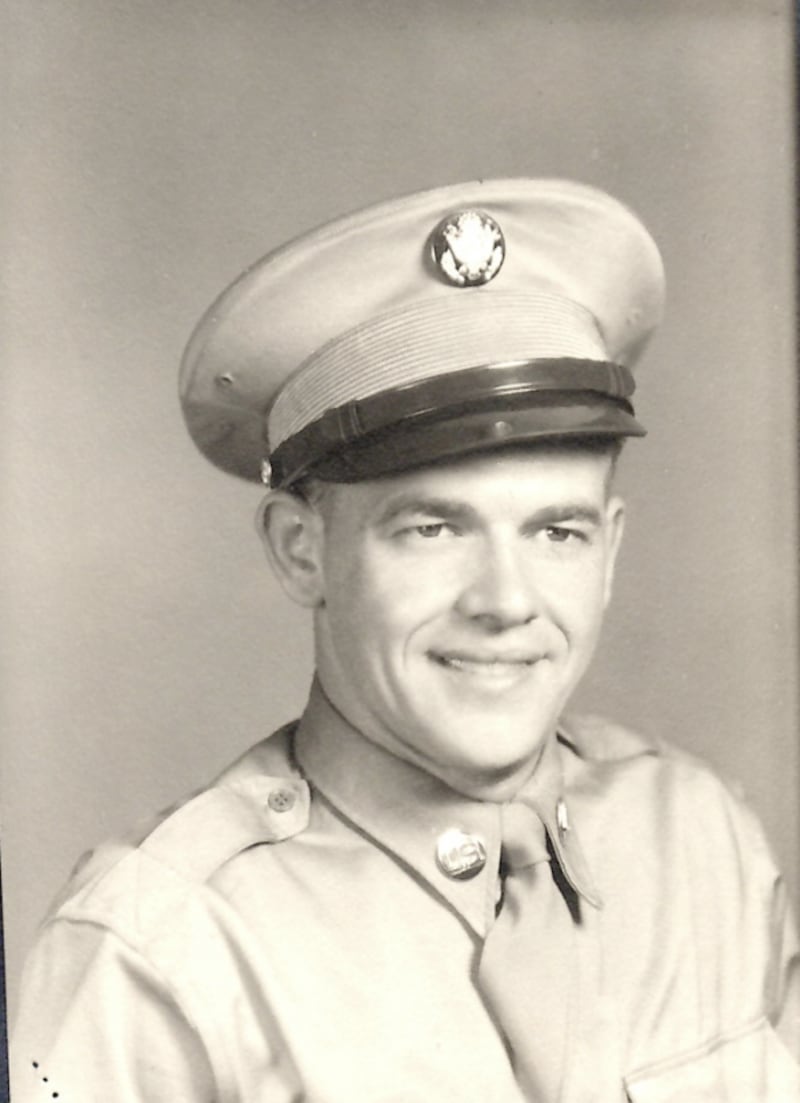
<box><xmin>0</xmin><ymin>0</ymin><xmax>798</xmax><ymax>1007</ymax></box>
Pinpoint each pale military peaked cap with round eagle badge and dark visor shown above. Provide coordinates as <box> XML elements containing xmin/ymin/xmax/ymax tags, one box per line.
<box><xmin>180</xmin><ymin>179</ymin><xmax>664</xmax><ymax>486</ymax></box>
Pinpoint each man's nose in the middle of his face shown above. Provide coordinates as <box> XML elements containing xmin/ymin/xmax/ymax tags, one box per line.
<box><xmin>457</xmin><ymin>543</ymin><xmax>541</xmax><ymax>632</ymax></box>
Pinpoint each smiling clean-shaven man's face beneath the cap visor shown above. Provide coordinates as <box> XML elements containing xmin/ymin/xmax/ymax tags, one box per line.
<box><xmin>308</xmin><ymin>448</ymin><xmax>622</xmax><ymax>799</ymax></box>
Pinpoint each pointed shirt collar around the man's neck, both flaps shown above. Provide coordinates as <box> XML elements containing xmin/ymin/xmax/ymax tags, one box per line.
<box><xmin>295</xmin><ymin>681</ymin><xmax>600</xmax><ymax>938</ymax></box>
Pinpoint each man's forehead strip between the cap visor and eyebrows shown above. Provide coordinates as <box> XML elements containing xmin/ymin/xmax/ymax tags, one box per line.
<box><xmin>320</xmin><ymin>446</ymin><xmax>614</xmax><ymax>516</ymax></box>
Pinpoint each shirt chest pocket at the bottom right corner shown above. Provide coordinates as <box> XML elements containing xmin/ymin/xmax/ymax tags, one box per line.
<box><xmin>626</xmin><ymin>1020</ymin><xmax>800</xmax><ymax>1103</ymax></box>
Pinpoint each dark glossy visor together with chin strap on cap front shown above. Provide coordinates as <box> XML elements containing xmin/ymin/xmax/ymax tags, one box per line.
<box><xmin>269</xmin><ymin>357</ymin><xmax>644</xmax><ymax>488</ymax></box>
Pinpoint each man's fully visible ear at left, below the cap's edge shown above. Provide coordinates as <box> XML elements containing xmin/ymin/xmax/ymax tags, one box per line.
<box><xmin>258</xmin><ymin>490</ymin><xmax>324</xmax><ymax>609</ymax></box>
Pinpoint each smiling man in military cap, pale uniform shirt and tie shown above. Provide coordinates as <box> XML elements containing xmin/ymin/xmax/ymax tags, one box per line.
<box><xmin>13</xmin><ymin>180</ymin><xmax>800</xmax><ymax>1103</ymax></box>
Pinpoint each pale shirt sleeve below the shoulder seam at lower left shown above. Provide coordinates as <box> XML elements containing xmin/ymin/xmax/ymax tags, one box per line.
<box><xmin>10</xmin><ymin>920</ymin><xmax>216</xmax><ymax>1103</ymax></box>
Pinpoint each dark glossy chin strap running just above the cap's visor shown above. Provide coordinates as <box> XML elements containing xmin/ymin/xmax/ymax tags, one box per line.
<box><xmin>269</xmin><ymin>357</ymin><xmax>634</xmax><ymax>486</ymax></box>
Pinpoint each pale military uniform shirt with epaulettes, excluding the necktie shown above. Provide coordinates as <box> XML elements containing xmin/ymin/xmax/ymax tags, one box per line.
<box><xmin>12</xmin><ymin>686</ymin><xmax>800</xmax><ymax>1103</ymax></box>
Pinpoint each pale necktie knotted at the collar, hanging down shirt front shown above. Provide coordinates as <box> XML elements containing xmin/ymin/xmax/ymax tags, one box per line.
<box><xmin>478</xmin><ymin>800</ymin><xmax>575</xmax><ymax>1103</ymax></box>
